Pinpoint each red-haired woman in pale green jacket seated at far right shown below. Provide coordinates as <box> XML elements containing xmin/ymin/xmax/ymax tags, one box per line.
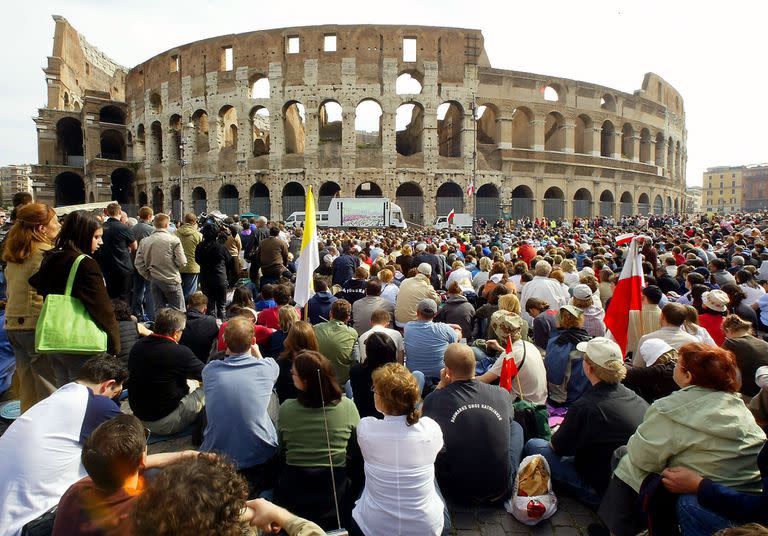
<box><xmin>598</xmin><ymin>343</ymin><xmax>765</xmax><ymax>536</ymax></box>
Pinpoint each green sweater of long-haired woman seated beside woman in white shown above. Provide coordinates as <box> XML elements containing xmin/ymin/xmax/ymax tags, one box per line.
<box><xmin>277</xmin><ymin>396</ymin><xmax>360</xmax><ymax>467</ymax></box>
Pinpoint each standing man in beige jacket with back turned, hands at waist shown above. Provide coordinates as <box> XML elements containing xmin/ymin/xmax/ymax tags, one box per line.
<box><xmin>136</xmin><ymin>213</ymin><xmax>187</xmax><ymax>315</ymax></box>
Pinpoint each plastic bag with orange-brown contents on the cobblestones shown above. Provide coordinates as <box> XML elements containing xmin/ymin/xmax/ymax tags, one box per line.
<box><xmin>504</xmin><ymin>454</ymin><xmax>557</xmax><ymax>525</ymax></box>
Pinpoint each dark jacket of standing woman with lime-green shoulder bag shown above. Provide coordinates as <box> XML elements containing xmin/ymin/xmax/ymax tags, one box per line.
<box><xmin>29</xmin><ymin>248</ymin><xmax>120</xmax><ymax>355</ymax></box>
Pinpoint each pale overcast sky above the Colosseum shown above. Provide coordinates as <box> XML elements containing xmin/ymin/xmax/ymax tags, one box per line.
<box><xmin>0</xmin><ymin>0</ymin><xmax>768</xmax><ymax>185</ymax></box>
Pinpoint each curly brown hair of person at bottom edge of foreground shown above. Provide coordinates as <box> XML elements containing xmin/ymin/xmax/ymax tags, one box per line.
<box><xmin>133</xmin><ymin>455</ymin><xmax>248</xmax><ymax>536</ymax></box>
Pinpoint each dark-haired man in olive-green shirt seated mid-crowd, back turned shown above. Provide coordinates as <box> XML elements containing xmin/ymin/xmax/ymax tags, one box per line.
<box><xmin>314</xmin><ymin>300</ymin><xmax>357</xmax><ymax>385</ymax></box>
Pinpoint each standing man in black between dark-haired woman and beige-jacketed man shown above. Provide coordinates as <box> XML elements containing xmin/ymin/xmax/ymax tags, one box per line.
<box><xmin>97</xmin><ymin>203</ymin><xmax>138</xmax><ymax>302</ymax></box>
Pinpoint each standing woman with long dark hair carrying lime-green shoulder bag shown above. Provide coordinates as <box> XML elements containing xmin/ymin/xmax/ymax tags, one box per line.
<box><xmin>29</xmin><ymin>210</ymin><xmax>120</xmax><ymax>387</ymax></box>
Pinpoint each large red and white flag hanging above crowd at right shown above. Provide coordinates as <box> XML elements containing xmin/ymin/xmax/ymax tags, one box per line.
<box><xmin>605</xmin><ymin>237</ymin><xmax>645</xmax><ymax>354</ymax></box>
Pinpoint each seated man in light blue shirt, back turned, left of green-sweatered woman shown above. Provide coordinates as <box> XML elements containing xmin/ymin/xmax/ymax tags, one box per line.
<box><xmin>200</xmin><ymin>317</ymin><xmax>280</xmax><ymax>495</ymax></box>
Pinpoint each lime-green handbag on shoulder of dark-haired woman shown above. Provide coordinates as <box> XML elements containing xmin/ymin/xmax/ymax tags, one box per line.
<box><xmin>35</xmin><ymin>255</ymin><xmax>107</xmax><ymax>355</ymax></box>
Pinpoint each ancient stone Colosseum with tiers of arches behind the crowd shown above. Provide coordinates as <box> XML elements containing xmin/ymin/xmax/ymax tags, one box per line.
<box><xmin>33</xmin><ymin>16</ymin><xmax>687</xmax><ymax>225</ymax></box>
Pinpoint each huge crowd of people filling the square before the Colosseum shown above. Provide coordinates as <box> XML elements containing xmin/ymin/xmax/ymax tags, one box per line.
<box><xmin>0</xmin><ymin>195</ymin><xmax>768</xmax><ymax>536</ymax></box>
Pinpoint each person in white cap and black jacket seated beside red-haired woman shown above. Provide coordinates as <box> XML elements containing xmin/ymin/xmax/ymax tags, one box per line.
<box><xmin>524</xmin><ymin>337</ymin><xmax>648</xmax><ymax>508</ymax></box>
